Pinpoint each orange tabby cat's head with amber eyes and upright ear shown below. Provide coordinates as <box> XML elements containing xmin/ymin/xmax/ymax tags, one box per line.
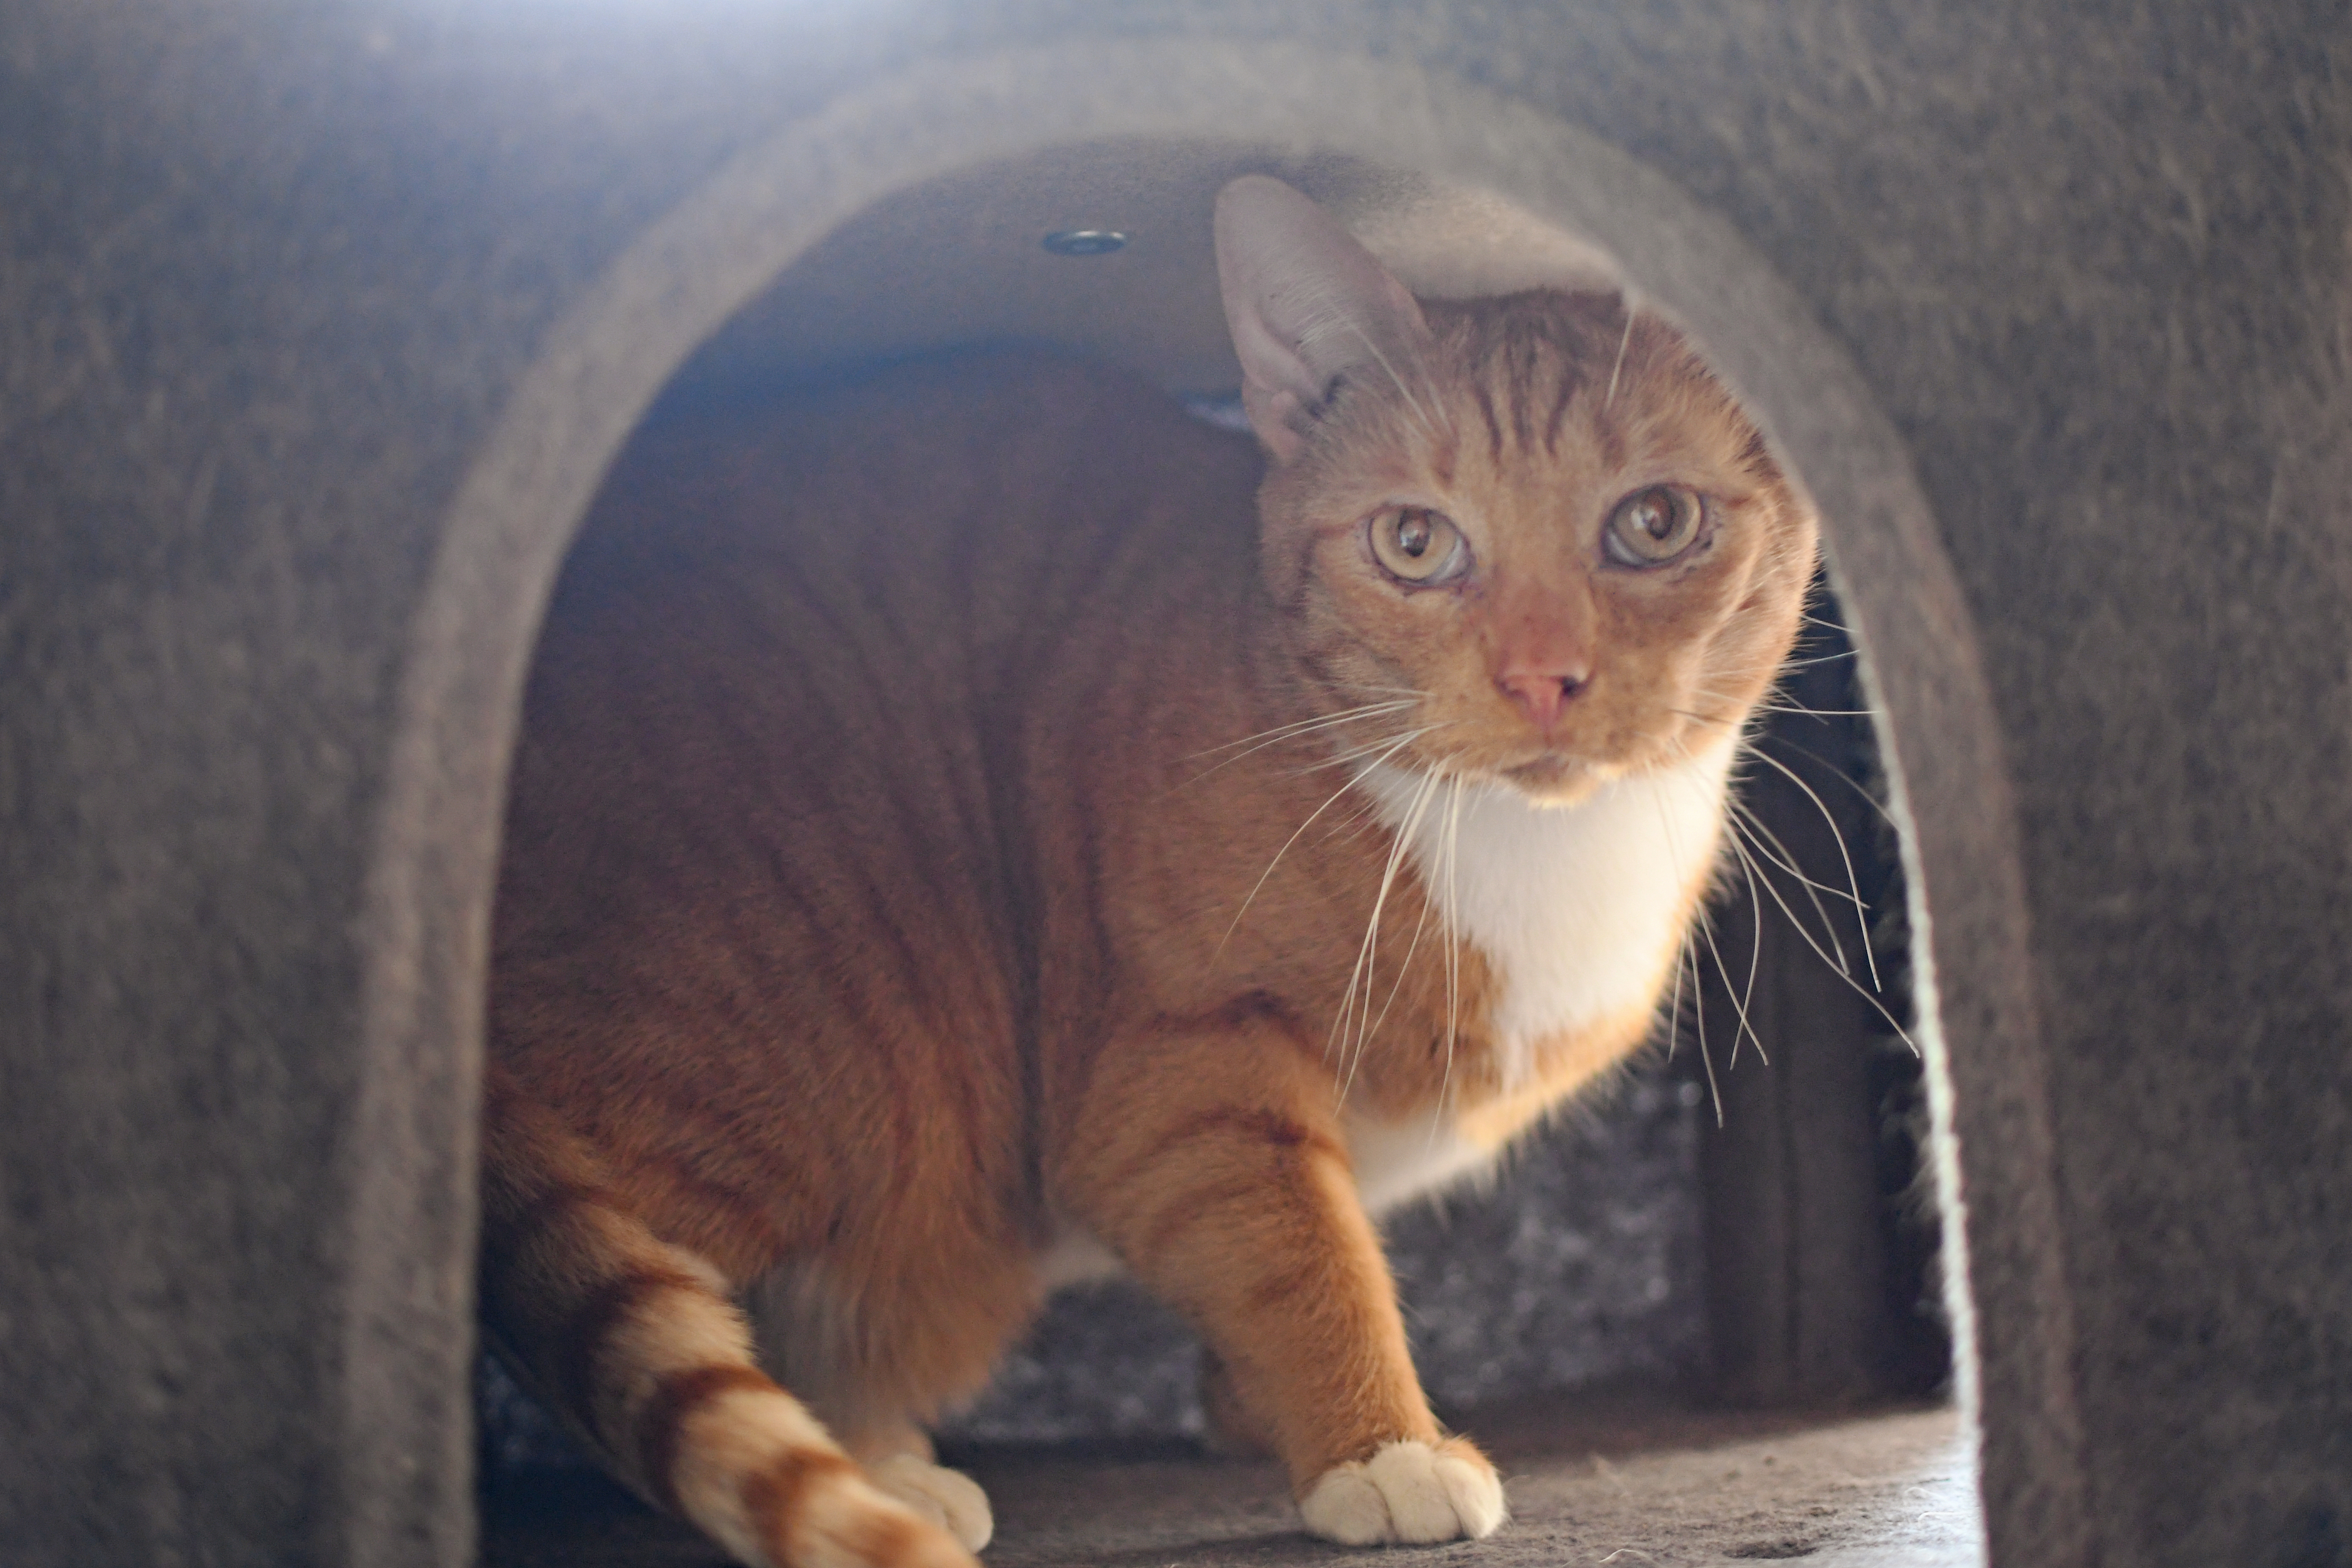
<box><xmin>1216</xmin><ymin>176</ymin><xmax>1818</xmax><ymax>804</ymax></box>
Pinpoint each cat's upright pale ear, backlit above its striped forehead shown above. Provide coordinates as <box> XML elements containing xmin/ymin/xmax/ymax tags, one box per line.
<box><xmin>1216</xmin><ymin>174</ymin><xmax>1430</xmax><ymax>463</ymax></box>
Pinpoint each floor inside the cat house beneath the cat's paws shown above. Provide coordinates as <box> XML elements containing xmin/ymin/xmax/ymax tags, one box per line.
<box><xmin>482</xmin><ymin>1401</ymin><xmax>1985</xmax><ymax>1568</ymax></box>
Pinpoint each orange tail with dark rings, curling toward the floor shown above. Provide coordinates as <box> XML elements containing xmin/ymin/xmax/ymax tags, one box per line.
<box><xmin>482</xmin><ymin>1067</ymin><xmax>974</xmax><ymax>1568</ymax></box>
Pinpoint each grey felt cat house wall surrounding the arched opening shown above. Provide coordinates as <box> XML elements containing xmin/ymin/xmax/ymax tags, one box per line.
<box><xmin>0</xmin><ymin>0</ymin><xmax>2352</xmax><ymax>1563</ymax></box>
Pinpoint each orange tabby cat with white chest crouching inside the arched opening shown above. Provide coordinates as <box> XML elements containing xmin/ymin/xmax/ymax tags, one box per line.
<box><xmin>482</xmin><ymin>176</ymin><xmax>1816</xmax><ymax>1568</ymax></box>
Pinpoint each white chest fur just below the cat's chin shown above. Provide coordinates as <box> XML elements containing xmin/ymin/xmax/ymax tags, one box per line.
<box><xmin>1362</xmin><ymin>743</ymin><xmax>1731</xmax><ymax>1084</ymax></box>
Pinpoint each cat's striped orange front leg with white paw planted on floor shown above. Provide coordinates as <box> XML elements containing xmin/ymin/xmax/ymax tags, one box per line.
<box><xmin>1063</xmin><ymin>1018</ymin><xmax>1505</xmax><ymax>1544</ymax></box>
